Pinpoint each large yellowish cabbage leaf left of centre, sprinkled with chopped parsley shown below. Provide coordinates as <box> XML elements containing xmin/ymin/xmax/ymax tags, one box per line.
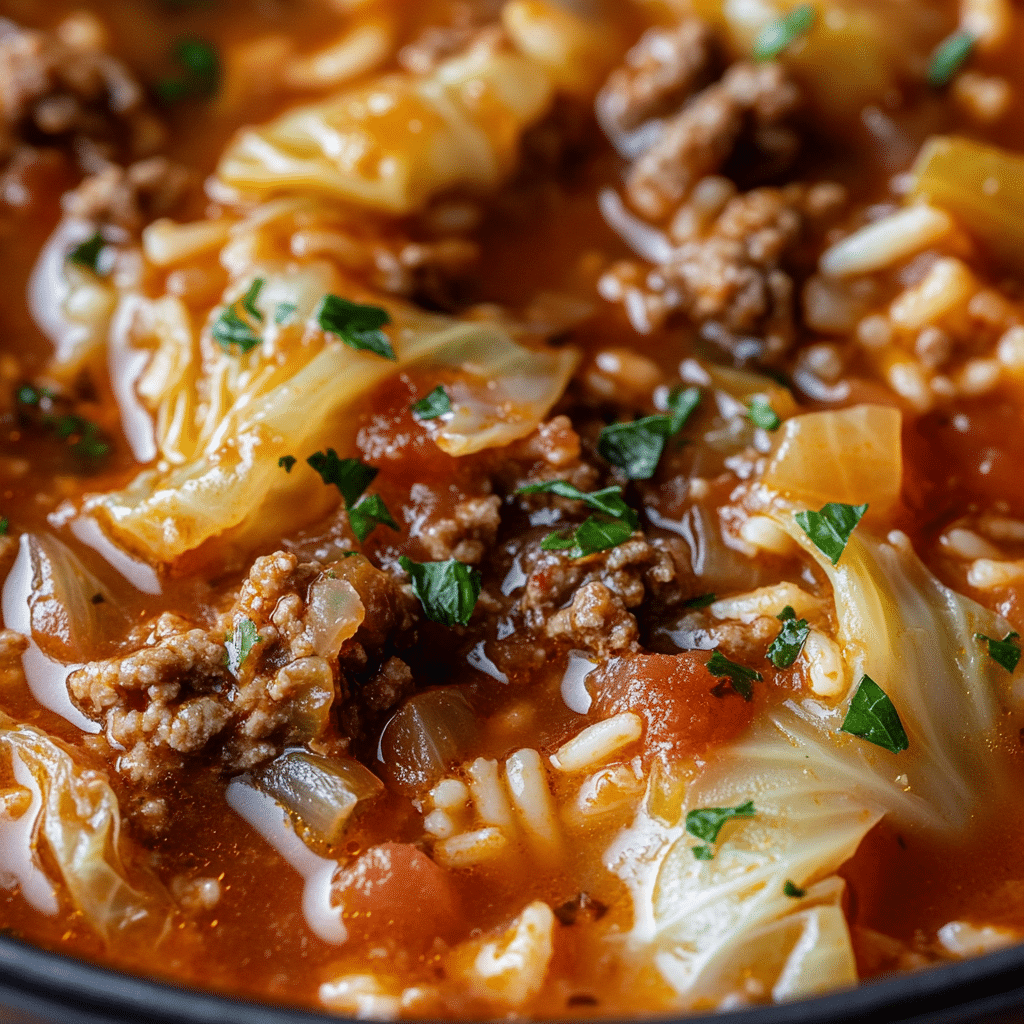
<box><xmin>87</xmin><ymin>254</ymin><xmax>578</xmax><ymax>562</ymax></box>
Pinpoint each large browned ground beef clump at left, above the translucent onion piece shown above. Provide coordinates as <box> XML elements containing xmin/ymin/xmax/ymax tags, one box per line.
<box><xmin>69</xmin><ymin>551</ymin><xmax>413</xmax><ymax>785</ymax></box>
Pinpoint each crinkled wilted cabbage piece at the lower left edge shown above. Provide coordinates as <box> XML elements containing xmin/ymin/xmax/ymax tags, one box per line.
<box><xmin>0</xmin><ymin>714</ymin><xmax>174</xmax><ymax>946</ymax></box>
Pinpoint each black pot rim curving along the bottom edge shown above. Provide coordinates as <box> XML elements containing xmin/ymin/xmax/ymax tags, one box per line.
<box><xmin>0</xmin><ymin>936</ymin><xmax>1024</xmax><ymax>1024</ymax></box>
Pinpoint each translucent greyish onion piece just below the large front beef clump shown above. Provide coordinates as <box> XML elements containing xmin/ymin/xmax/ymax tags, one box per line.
<box><xmin>252</xmin><ymin>751</ymin><xmax>384</xmax><ymax>846</ymax></box>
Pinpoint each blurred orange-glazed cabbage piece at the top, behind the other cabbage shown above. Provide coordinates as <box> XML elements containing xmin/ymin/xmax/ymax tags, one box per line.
<box><xmin>217</xmin><ymin>40</ymin><xmax>554</xmax><ymax>214</ymax></box>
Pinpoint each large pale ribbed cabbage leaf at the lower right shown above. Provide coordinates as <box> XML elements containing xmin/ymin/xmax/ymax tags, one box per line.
<box><xmin>636</xmin><ymin>500</ymin><xmax>1021</xmax><ymax>1005</ymax></box>
